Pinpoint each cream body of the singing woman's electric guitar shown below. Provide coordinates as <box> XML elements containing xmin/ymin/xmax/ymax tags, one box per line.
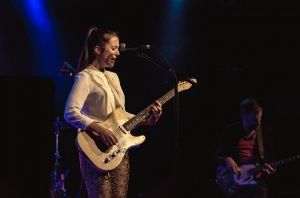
<box><xmin>76</xmin><ymin>108</ymin><xmax>145</xmax><ymax>172</ymax></box>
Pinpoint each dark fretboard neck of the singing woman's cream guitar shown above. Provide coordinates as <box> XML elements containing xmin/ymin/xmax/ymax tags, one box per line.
<box><xmin>123</xmin><ymin>88</ymin><xmax>175</xmax><ymax>131</ymax></box>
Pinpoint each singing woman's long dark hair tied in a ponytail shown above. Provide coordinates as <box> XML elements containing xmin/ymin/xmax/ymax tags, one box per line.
<box><xmin>76</xmin><ymin>26</ymin><xmax>119</xmax><ymax>73</ymax></box>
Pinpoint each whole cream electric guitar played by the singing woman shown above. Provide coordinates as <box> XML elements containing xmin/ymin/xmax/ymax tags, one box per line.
<box><xmin>76</xmin><ymin>78</ymin><xmax>197</xmax><ymax>172</ymax></box>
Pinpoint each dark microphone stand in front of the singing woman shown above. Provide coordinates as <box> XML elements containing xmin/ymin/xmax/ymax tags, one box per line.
<box><xmin>136</xmin><ymin>51</ymin><xmax>180</xmax><ymax>171</ymax></box>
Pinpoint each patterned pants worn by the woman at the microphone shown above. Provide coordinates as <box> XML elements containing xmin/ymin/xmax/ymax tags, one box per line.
<box><xmin>79</xmin><ymin>152</ymin><xmax>129</xmax><ymax>198</ymax></box>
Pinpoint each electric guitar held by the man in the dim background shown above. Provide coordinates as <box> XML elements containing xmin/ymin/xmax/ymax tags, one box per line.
<box><xmin>216</xmin><ymin>155</ymin><xmax>300</xmax><ymax>197</ymax></box>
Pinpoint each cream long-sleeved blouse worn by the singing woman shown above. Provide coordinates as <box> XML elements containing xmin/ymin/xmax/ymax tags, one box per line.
<box><xmin>64</xmin><ymin>65</ymin><xmax>134</xmax><ymax>130</ymax></box>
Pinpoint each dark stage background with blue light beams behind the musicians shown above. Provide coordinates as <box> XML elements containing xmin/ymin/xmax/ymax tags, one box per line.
<box><xmin>0</xmin><ymin>0</ymin><xmax>300</xmax><ymax>198</ymax></box>
